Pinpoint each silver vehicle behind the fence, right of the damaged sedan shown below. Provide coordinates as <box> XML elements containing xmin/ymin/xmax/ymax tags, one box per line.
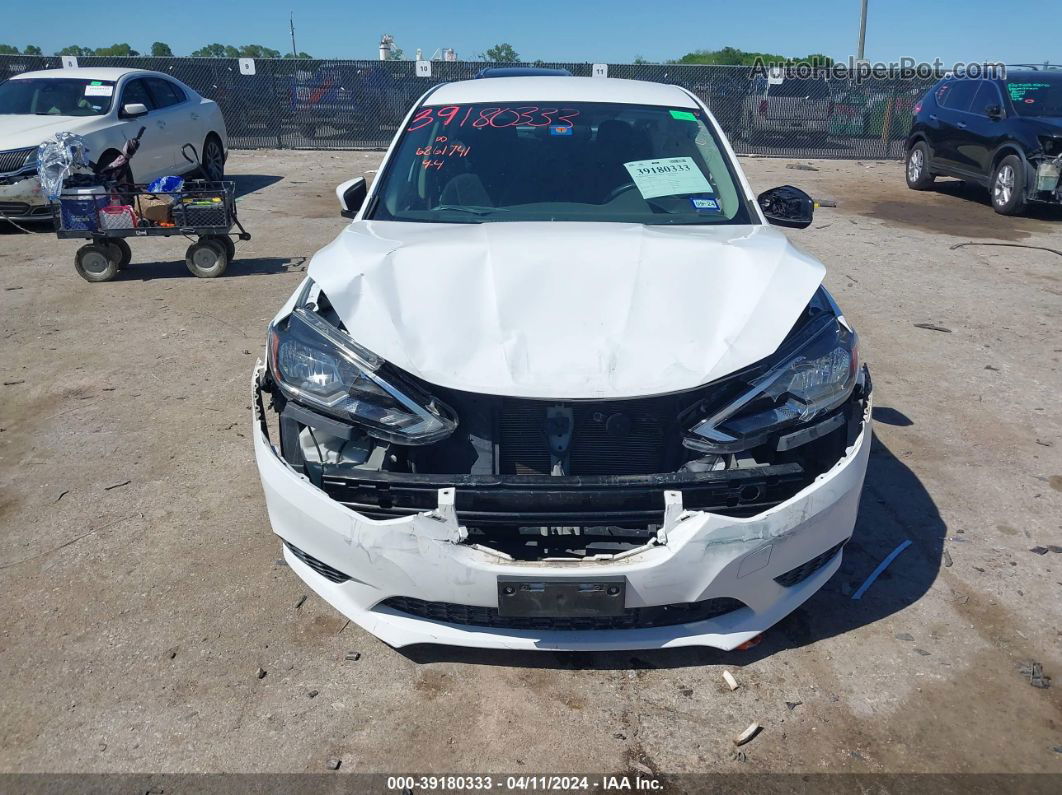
<box><xmin>741</xmin><ymin>77</ymin><xmax>833</xmax><ymax>137</ymax></box>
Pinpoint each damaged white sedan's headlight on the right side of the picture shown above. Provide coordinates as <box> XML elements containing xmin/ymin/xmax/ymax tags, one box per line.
<box><xmin>683</xmin><ymin>315</ymin><xmax>859</xmax><ymax>453</ymax></box>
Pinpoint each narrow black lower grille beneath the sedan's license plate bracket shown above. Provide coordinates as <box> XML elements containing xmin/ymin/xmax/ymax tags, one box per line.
<box><xmin>378</xmin><ymin>597</ymin><xmax>744</xmax><ymax>630</ymax></box>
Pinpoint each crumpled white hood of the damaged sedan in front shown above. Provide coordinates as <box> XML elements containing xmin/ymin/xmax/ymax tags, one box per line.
<box><xmin>309</xmin><ymin>221</ymin><xmax>824</xmax><ymax>399</ymax></box>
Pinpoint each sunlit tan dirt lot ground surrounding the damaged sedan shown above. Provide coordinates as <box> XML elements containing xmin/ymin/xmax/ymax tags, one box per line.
<box><xmin>0</xmin><ymin>151</ymin><xmax>1062</xmax><ymax>774</ymax></box>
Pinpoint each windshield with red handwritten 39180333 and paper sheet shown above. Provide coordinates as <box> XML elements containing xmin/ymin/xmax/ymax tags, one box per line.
<box><xmin>366</xmin><ymin>102</ymin><xmax>753</xmax><ymax>224</ymax></box>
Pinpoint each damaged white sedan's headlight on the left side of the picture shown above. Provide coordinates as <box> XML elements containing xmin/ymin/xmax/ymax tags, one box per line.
<box><xmin>269</xmin><ymin>307</ymin><xmax>457</xmax><ymax>445</ymax></box>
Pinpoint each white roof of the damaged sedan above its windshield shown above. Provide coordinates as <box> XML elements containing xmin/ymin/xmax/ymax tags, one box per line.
<box><xmin>424</xmin><ymin>76</ymin><xmax>698</xmax><ymax>108</ymax></box>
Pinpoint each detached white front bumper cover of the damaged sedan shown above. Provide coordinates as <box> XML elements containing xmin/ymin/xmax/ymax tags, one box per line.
<box><xmin>253</xmin><ymin>370</ymin><xmax>871</xmax><ymax>651</ymax></box>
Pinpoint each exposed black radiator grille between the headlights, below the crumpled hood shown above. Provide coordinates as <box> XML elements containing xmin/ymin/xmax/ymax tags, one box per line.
<box><xmin>499</xmin><ymin>397</ymin><xmax>679</xmax><ymax>476</ymax></box>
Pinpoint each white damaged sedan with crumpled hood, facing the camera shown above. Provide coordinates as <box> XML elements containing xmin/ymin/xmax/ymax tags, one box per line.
<box><xmin>254</xmin><ymin>76</ymin><xmax>871</xmax><ymax>650</ymax></box>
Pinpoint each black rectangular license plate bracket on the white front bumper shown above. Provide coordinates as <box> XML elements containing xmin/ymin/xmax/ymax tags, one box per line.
<box><xmin>498</xmin><ymin>576</ymin><xmax>627</xmax><ymax>619</ymax></box>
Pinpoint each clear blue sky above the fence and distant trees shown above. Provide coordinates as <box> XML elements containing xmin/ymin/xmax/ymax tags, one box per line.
<box><xmin>0</xmin><ymin>0</ymin><xmax>1062</xmax><ymax>65</ymax></box>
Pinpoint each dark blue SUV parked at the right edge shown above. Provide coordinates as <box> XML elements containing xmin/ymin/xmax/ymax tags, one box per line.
<box><xmin>907</xmin><ymin>68</ymin><xmax>1062</xmax><ymax>215</ymax></box>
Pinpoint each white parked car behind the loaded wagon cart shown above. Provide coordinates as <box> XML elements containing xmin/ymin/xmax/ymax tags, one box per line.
<box><xmin>0</xmin><ymin>68</ymin><xmax>228</xmax><ymax>221</ymax></box>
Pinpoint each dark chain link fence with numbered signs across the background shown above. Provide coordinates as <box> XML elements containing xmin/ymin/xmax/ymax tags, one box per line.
<box><xmin>0</xmin><ymin>55</ymin><xmax>932</xmax><ymax>159</ymax></box>
